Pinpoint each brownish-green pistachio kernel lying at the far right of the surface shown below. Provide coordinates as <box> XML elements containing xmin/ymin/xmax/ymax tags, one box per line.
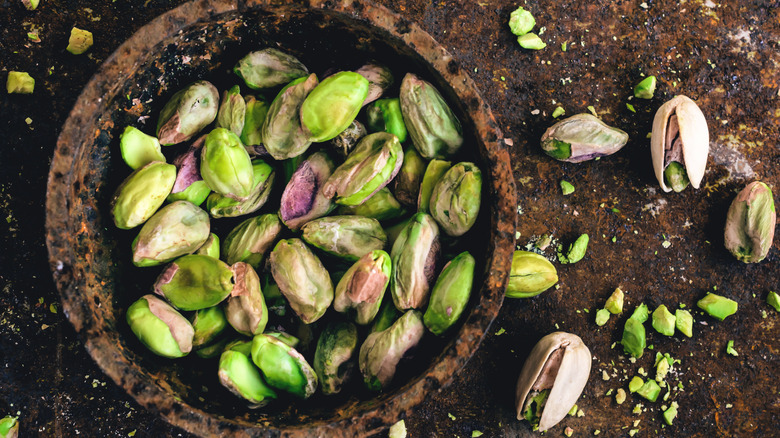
<box><xmin>724</xmin><ymin>181</ymin><xmax>777</xmax><ymax>263</ymax></box>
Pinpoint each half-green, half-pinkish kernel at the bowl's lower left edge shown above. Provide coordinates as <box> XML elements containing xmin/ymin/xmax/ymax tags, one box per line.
<box><xmin>127</xmin><ymin>295</ymin><xmax>195</xmax><ymax>358</ymax></box>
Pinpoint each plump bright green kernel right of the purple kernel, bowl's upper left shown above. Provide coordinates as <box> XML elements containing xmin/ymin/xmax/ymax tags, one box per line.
<box><xmin>200</xmin><ymin>128</ymin><xmax>255</xmax><ymax>201</ymax></box>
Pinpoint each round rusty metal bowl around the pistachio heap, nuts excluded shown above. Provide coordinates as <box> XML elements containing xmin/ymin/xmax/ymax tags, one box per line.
<box><xmin>46</xmin><ymin>0</ymin><xmax>516</xmax><ymax>437</ymax></box>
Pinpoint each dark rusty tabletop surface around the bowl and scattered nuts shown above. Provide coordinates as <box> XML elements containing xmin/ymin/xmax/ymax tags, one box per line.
<box><xmin>0</xmin><ymin>0</ymin><xmax>780</xmax><ymax>437</ymax></box>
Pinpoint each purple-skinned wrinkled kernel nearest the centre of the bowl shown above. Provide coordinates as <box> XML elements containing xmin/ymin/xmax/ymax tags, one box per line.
<box><xmin>279</xmin><ymin>152</ymin><xmax>336</xmax><ymax>230</ymax></box>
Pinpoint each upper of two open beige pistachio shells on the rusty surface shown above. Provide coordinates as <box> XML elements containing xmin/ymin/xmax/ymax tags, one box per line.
<box><xmin>650</xmin><ymin>95</ymin><xmax>710</xmax><ymax>192</ymax></box>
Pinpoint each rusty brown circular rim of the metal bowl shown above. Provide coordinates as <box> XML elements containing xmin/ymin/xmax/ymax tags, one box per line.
<box><xmin>46</xmin><ymin>0</ymin><xmax>516</xmax><ymax>437</ymax></box>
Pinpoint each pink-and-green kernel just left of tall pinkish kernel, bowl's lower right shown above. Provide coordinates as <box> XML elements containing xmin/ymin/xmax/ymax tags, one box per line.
<box><xmin>333</xmin><ymin>250</ymin><xmax>392</xmax><ymax>325</ymax></box>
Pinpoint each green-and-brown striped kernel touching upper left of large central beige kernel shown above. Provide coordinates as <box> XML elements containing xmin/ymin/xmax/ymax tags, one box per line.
<box><xmin>222</xmin><ymin>214</ymin><xmax>282</xmax><ymax>269</ymax></box>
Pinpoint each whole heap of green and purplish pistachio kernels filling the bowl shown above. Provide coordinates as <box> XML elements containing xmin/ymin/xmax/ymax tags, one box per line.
<box><xmin>111</xmin><ymin>48</ymin><xmax>482</xmax><ymax>407</ymax></box>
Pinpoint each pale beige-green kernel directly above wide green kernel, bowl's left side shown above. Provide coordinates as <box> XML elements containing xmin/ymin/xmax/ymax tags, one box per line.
<box><xmin>132</xmin><ymin>201</ymin><xmax>211</xmax><ymax>267</ymax></box>
